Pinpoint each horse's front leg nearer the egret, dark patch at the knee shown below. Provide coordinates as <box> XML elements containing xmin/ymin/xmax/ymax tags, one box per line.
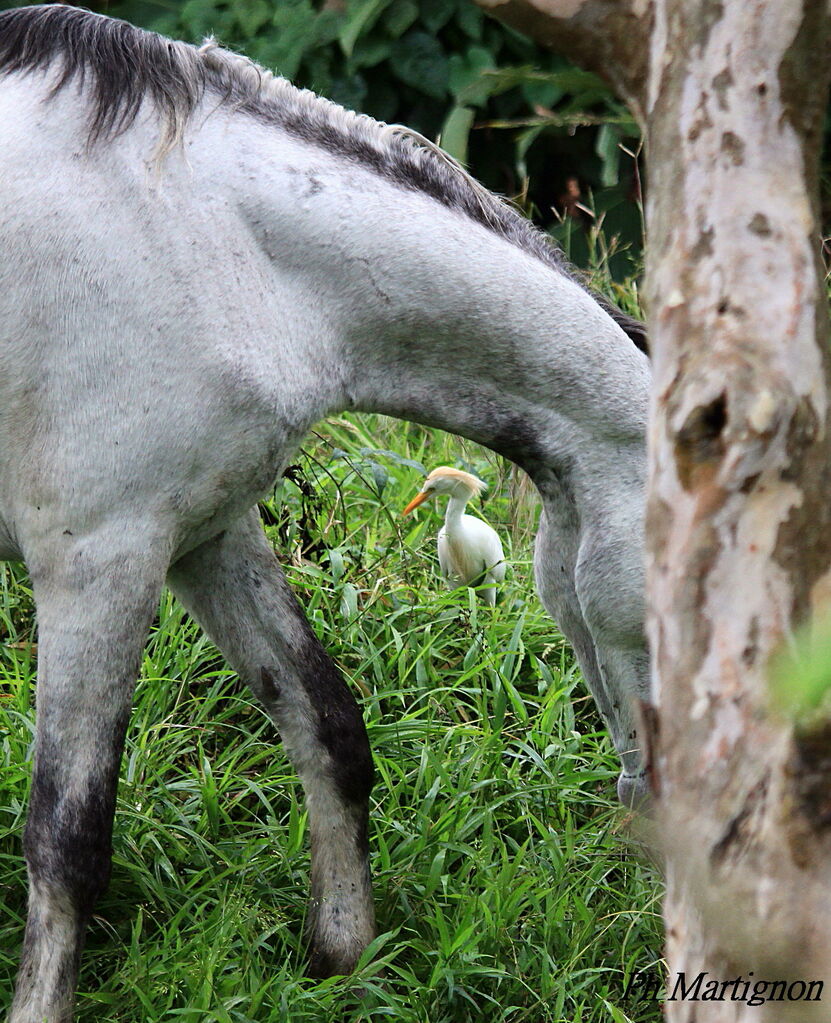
<box><xmin>168</xmin><ymin>513</ymin><xmax>375</xmax><ymax>976</ymax></box>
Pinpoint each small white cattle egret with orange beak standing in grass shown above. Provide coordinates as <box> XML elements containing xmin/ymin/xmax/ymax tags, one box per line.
<box><xmin>401</xmin><ymin>465</ymin><xmax>506</xmax><ymax>607</ymax></box>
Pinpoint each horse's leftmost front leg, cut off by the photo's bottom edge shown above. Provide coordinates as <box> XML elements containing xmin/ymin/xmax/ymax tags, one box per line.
<box><xmin>9</xmin><ymin>526</ymin><xmax>166</xmax><ymax>1023</ymax></box>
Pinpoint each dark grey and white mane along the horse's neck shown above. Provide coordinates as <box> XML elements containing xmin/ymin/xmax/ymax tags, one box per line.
<box><xmin>0</xmin><ymin>4</ymin><xmax>647</xmax><ymax>351</ymax></box>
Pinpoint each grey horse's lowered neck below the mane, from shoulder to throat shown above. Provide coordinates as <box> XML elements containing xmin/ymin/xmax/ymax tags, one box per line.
<box><xmin>192</xmin><ymin>116</ymin><xmax>648</xmax><ymax>488</ymax></box>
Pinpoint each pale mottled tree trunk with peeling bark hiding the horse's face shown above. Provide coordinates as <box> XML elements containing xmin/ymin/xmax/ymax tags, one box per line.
<box><xmin>480</xmin><ymin>0</ymin><xmax>831</xmax><ymax>1023</ymax></box>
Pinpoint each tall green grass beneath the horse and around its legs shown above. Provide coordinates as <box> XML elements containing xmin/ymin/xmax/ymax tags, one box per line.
<box><xmin>0</xmin><ymin>417</ymin><xmax>661</xmax><ymax>1023</ymax></box>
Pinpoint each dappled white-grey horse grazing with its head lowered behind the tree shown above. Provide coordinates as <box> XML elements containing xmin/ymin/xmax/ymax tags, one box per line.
<box><xmin>0</xmin><ymin>6</ymin><xmax>649</xmax><ymax>1023</ymax></box>
